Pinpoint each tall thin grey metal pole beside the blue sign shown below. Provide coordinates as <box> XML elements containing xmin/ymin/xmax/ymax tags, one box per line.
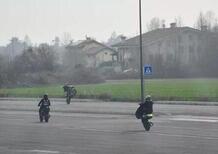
<box><xmin>139</xmin><ymin>0</ymin><xmax>144</xmax><ymax>103</ymax></box>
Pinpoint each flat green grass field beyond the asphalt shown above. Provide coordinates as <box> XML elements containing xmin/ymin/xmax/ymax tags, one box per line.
<box><xmin>0</xmin><ymin>79</ymin><xmax>218</xmax><ymax>101</ymax></box>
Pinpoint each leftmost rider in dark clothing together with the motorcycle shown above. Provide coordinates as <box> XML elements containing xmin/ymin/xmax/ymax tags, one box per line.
<box><xmin>38</xmin><ymin>94</ymin><xmax>51</xmax><ymax>122</ymax></box>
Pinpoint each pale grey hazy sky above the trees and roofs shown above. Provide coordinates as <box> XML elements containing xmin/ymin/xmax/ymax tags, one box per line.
<box><xmin>0</xmin><ymin>0</ymin><xmax>218</xmax><ymax>45</ymax></box>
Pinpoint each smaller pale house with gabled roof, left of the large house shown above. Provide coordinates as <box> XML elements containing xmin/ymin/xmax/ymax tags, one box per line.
<box><xmin>66</xmin><ymin>38</ymin><xmax>118</xmax><ymax>68</ymax></box>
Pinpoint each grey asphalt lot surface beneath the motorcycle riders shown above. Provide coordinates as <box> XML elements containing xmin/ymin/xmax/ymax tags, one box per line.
<box><xmin>0</xmin><ymin>100</ymin><xmax>218</xmax><ymax>154</ymax></box>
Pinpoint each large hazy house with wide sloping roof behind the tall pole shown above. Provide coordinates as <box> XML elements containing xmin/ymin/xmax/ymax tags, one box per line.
<box><xmin>113</xmin><ymin>23</ymin><xmax>216</xmax><ymax>76</ymax></box>
